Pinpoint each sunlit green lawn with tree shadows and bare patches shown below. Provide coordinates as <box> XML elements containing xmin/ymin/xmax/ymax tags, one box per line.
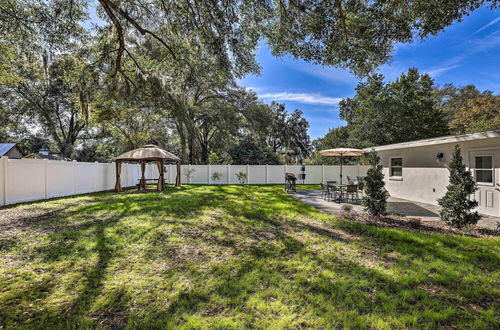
<box><xmin>0</xmin><ymin>186</ymin><xmax>500</xmax><ymax>328</ymax></box>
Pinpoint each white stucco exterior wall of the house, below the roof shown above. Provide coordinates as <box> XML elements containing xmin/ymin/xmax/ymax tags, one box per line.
<box><xmin>378</xmin><ymin>138</ymin><xmax>500</xmax><ymax>216</ymax></box>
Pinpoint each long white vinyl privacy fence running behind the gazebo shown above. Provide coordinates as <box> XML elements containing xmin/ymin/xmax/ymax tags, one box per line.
<box><xmin>0</xmin><ymin>157</ymin><xmax>368</xmax><ymax>205</ymax></box>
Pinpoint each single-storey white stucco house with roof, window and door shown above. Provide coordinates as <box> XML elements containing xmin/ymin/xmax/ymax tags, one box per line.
<box><xmin>365</xmin><ymin>130</ymin><xmax>500</xmax><ymax>217</ymax></box>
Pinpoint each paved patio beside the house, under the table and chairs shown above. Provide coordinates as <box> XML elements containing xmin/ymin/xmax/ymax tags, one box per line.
<box><xmin>290</xmin><ymin>190</ymin><xmax>500</xmax><ymax>230</ymax></box>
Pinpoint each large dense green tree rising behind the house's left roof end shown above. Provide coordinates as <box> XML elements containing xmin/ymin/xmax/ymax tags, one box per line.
<box><xmin>340</xmin><ymin>69</ymin><xmax>448</xmax><ymax>147</ymax></box>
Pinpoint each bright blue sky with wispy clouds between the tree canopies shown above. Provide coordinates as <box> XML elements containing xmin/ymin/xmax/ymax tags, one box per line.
<box><xmin>239</xmin><ymin>8</ymin><xmax>500</xmax><ymax>139</ymax></box>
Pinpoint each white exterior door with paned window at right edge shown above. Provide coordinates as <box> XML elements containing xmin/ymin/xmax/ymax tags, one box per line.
<box><xmin>469</xmin><ymin>149</ymin><xmax>500</xmax><ymax>217</ymax></box>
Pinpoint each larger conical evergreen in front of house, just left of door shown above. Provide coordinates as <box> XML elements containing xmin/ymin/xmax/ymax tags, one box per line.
<box><xmin>438</xmin><ymin>145</ymin><xmax>481</xmax><ymax>228</ymax></box>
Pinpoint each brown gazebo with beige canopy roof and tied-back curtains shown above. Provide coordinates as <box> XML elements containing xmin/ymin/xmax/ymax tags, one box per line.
<box><xmin>115</xmin><ymin>144</ymin><xmax>181</xmax><ymax>192</ymax></box>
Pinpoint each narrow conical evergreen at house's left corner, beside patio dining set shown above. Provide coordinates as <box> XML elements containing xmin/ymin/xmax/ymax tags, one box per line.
<box><xmin>363</xmin><ymin>151</ymin><xmax>389</xmax><ymax>216</ymax></box>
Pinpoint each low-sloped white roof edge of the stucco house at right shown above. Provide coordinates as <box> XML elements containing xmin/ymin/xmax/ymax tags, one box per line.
<box><xmin>364</xmin><ymin>130</ymin><xmax>500</xmax><ymax>151</ymax></box>
